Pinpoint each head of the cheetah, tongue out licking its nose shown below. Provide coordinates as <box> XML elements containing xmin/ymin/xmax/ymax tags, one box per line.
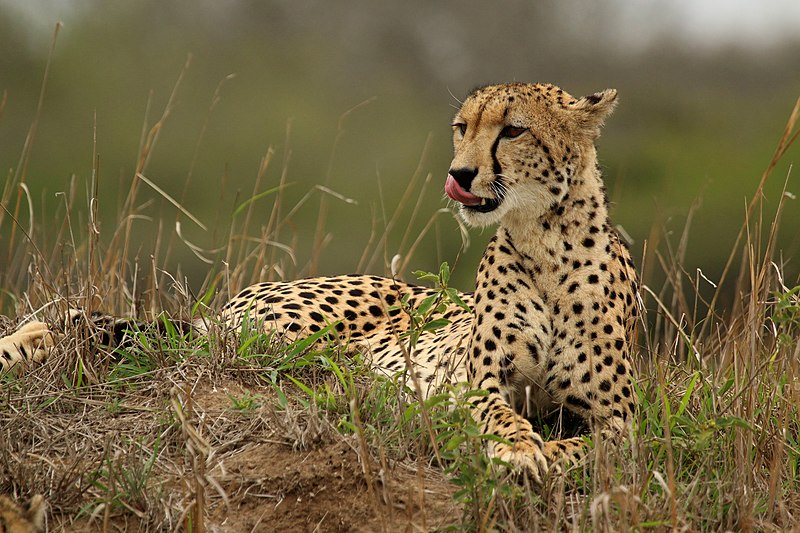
<box><xmin>445</xmin><ymin>83</ymin><xmax>617</xmax><ymax>226</ymax></box>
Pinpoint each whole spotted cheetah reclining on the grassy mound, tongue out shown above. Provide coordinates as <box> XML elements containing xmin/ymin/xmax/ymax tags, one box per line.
<box><xmin>0</xmin><ymin>83</ymin><xmax>637</xmax><ymax>483</ymax></box>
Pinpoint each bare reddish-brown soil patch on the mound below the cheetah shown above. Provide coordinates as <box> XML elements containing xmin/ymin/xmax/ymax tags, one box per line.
<box><xmin>216</xmin><ymin>441</ymin><xmax>458</xmax><ymax>531</ymax></box>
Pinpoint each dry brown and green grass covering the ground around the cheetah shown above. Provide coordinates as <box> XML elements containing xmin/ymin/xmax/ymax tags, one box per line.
<box><xmin>0</xmin><ymin>30</ymin><xmax>800</xmax><ymax>531</ymax></box>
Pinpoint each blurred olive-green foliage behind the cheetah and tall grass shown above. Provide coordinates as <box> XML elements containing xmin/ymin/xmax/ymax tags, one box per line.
<box><xmin>0</xmin><ymin>0</ymin><xmax>800</xmax><ymax>298</ymax></box>
